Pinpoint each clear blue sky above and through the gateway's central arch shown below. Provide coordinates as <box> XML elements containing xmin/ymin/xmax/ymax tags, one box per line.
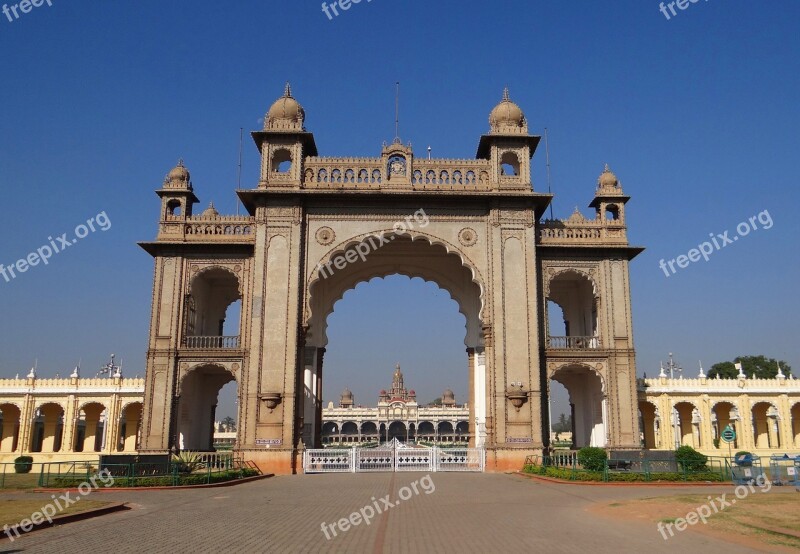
<box><xmin>0</xmin><ymin>0</ymin><xmax>800</xmax><ymax>415</ymax></box>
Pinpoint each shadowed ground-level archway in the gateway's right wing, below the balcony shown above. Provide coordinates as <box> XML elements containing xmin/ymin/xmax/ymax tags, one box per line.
<box><xmin>550</xmin><ymin>364</ymin><xmax>607</xmax><ymax>449</ymax></box>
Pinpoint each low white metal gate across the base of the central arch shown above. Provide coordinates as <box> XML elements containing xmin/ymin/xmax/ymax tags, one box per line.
<box><xmin>303</xmin><ymin>440</ymin><xmax>486</xmax><ymax>473</ymax></box>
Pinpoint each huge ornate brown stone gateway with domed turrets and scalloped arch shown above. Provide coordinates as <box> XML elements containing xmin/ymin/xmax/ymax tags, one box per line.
<box><xmin>142</xmin><ymin>86</ymin><xmax>641</xmax><ymax>473</ymax></box>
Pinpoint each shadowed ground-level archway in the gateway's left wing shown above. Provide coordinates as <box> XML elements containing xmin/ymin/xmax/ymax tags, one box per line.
<box><xmin>177</xmin><ymin>364</ymin><xmax>235</xmax><ymax>452</ymax></box>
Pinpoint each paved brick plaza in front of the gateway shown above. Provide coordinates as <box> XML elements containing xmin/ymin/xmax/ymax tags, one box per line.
<box><xmin>0</xmin><ymin>473</ymin><xmax>752</xmax><ymax>554</ymax></box>
